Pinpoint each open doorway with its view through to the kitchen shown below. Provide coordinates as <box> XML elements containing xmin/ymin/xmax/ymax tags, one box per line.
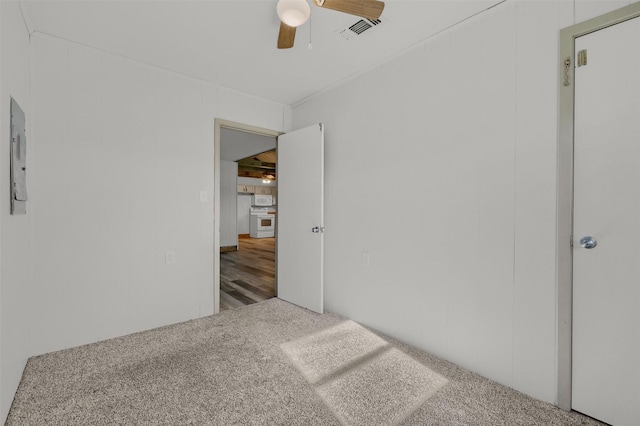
<box><xmin>214</xmin><ymin>119</ymin><xmax>280</xmax><ymax>313</ymax></box>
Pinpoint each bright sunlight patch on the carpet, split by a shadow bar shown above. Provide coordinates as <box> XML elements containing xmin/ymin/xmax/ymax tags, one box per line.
<box><xmin>281</xmin><ymin>321</ymin><xmax>448</xmax><ymax>426</ymax></box>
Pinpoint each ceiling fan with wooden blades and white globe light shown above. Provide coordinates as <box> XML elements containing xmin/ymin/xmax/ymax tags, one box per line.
<box><xmin>276</xmin><ymin>0</ymin><xmax>384</xmax><ymax>49</ymax></box>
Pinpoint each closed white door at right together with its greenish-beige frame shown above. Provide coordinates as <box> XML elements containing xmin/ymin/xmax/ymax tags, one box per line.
<box><xmin>557</xmin><ymin>3</ymin><xmax>640</xmax><ymax>425</ymax></box>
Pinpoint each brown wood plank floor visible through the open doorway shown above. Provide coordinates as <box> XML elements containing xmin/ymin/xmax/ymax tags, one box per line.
<box><xmin>220</xmin><ymin>238</ymin><xmax>276</xmax><ymax>311</ymax></box>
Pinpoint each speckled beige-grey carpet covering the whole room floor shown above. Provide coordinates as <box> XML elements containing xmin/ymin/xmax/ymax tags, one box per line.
<box><xmin>6</xmin><ymin>299</ymin><xmax>600</xmax><ymax>426</ymax></box>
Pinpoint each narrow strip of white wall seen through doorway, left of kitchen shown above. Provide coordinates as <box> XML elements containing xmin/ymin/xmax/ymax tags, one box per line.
<box><xmin>220</xmin><ymin>160</ymin><xmax>238</xmax><ymax>247</ymax></box>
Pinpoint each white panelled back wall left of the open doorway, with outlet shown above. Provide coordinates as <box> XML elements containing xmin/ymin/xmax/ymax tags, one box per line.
<box><xmin>31</xmin><ymin>32</ymin><xmax>216</xmax><ymax>354</ymax></box>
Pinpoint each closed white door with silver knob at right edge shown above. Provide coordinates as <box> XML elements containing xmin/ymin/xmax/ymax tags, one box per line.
<box><xmin>572</xmin><ymin>18</ymin><xmax>640</xmax><ymax>426</ymax></box>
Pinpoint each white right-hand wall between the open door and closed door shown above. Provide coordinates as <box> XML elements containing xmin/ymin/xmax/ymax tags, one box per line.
<box><xmin>293</xmin><ymin>1</ymin><xmax>629</xmax><ymax>402</ymax></box>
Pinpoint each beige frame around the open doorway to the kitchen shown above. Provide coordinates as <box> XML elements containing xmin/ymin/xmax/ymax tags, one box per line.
<box><xmin>213</xmin><ymin>118</ymin><xmax>283</xmax><ymax>314</ymax></box>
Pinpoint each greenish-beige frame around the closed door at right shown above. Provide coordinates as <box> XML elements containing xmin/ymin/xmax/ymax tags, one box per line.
<box><xmin>556</xmin><ymin>2</ymin><xmax>640</xmax><ymax>410</ymax></box>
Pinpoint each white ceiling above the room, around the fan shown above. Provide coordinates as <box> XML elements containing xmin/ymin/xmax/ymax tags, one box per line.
<box><xmin>22</xmin><ymin>0</ymin><xmax>503</xmax><ymax>105</ymax></box>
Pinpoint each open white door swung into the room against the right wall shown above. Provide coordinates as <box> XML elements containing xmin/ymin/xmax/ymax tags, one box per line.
<box><xmin>277</xmin><ymin>124</ymin><xmax>324</xmax><ymax>313</ymax></box>
